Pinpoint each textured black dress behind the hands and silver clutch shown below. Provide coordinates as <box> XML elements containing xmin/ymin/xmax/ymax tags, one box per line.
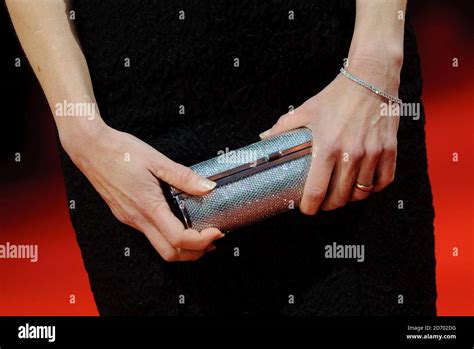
<box><xmin>61</xmin><ymin>0</ymin><xmax>436</xmax><ymax>315</ymax></box>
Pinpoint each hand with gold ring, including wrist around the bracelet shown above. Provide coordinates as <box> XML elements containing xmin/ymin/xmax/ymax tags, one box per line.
<box><xmin>261</xmin><ymin>57</ymin><xmax>401</xmax><ymax>215</ymax></box>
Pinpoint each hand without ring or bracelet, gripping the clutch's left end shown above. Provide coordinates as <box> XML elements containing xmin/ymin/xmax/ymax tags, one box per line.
<box><xmin>60</xmin><ymin>125</ymin><xmax>224</xmax><ymax>261</ymax></box>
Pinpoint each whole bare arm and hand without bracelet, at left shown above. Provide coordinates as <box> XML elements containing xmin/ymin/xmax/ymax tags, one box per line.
<box><xmin>7</xmin><ymin>0</ymin><xmax>223</xmax><ymax>261</ymax></box>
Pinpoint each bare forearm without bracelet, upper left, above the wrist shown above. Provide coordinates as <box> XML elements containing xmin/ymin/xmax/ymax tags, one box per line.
<box><xmin>6</xmin><ymin>0</ymin><xmax>103</xmax><ymax>142</ymax></box>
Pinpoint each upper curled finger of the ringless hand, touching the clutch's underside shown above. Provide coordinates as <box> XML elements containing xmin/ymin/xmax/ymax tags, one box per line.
<box><xmin>147</xmin><ymin>204</ymin><xmax>224</xmax><ymax>251</ymax></box>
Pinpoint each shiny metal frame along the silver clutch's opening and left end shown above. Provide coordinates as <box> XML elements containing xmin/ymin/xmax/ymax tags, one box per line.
<box><xmin>162</xmin><ymin>137</ymin><xmax>312</xmax><ymax>229</ymax></box>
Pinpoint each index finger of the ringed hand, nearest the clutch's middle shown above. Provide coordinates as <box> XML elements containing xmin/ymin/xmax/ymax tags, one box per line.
<box><xmin>300</xmin><ymin>149</ymin><xmax>335</xmax><ymax>215</ymax></box>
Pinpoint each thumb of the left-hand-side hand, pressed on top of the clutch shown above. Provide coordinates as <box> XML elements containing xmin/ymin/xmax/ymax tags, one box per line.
<box><xmin>152</xmin><ymin>154</ymin><xmax>216</xmax><ymax>195</ymax></box>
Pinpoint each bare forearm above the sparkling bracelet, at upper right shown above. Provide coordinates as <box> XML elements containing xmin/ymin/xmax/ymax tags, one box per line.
<box><xmin>348</xmin><ymin>0</ymin><xmax>407</xmax><ymax>94</ymax></box>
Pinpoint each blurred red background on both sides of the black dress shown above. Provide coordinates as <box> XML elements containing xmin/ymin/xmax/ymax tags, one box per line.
<box><xmin>0</xmin><ymin>1</ymin><xmax>474</xmax><ymax>315</ymax></box>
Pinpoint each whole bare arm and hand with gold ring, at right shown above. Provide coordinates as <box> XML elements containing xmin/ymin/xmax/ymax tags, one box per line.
<box><xmin>261</xmin><ymin>0</ymin><xmax>406</xmax><ymax>214</ymax></box>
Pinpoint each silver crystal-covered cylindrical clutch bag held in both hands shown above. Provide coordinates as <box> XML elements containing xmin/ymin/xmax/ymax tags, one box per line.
<box><xmin>163</xmin><ymin>128</ymin><xmax>312</xmax><ymax>232</ymax></box>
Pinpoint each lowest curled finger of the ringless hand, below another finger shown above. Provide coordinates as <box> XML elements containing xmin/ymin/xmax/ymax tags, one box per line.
<box><xmin>143</xmin><ymin>224</ymin><xmax>206</xmax><ymax>262</ymax></box>
